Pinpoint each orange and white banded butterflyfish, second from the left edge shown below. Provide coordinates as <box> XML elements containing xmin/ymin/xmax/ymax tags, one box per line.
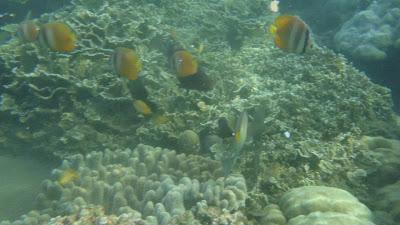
<box><xmin>39</xmin><ymin>22</ymin><xmax>76</xmax><ymax>52</ymax></box>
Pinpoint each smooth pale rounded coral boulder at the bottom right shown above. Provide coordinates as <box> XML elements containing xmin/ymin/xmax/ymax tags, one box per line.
<box><xmin>280</xmin><ymin>186</ymin><xmax>373</xmax><ymax>225</ymax></box>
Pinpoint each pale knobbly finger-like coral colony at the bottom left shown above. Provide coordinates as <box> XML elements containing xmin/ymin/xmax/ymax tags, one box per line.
<box><xmin>34</xmin><ymin>145</ymin><xmax>247</xmax><ymax>224</ymax></box>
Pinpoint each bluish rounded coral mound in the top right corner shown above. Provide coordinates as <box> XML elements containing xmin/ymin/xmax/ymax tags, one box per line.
<box><xmin>335</xmin><ymin>0</ymin><xmax>400</xmax><ymax>61</ymax></box>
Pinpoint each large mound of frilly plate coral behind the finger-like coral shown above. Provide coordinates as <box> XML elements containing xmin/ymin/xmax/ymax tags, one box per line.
<box><xmin>0</xmin><ymin>1</ymin><xmax>392</xmax><ymax>156</ymax></box>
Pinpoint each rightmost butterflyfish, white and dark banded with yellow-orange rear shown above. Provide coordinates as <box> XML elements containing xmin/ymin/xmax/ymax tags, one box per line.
<box><xmin>269</xmin><ymin>15</ymin><xmax>312</xmax><ymax>53</ymax></box>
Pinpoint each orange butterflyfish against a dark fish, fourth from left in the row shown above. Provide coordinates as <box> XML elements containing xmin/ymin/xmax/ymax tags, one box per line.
<box><xmin>173</xmin><ymin>50</ymin><xmax>198</xmax><ymax>77</ymax></box>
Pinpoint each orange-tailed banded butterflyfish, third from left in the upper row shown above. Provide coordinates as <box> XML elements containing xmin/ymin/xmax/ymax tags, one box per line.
<box><xmin>112</xmin><ymin>48</ymin><xmax>142</xmax><ymax>80</ymax></box>
